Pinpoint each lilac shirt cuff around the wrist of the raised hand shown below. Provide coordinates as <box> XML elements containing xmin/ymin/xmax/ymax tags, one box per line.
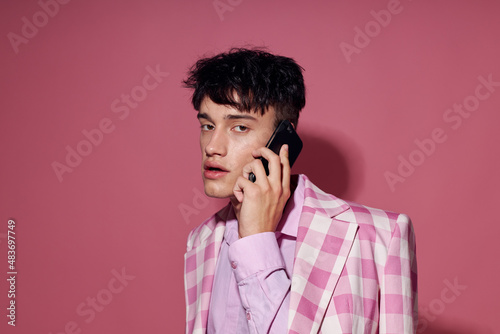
<box><xmin>228</xmin><ymin>232</ymin><xmax>285</xmax><ymax>283</ymax></box>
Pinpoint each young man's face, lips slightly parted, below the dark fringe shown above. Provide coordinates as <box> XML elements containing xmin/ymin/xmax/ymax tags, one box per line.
<box><xmin>198</xmin><ymin>98</ymin><xmax>275</xmax><ymax>198</ymax></box>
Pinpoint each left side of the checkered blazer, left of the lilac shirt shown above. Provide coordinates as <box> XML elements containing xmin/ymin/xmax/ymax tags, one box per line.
<box><xmin>185</xmin><ymin>206</ymin><xmax>229</xmax><ymax>334</ymax></box>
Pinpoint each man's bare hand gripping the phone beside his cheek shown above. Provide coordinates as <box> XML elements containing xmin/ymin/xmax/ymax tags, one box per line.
<box><xmin>233</xmin><ymin>145</ymin><xmax>290</xmax><ymax>238</ymax></box>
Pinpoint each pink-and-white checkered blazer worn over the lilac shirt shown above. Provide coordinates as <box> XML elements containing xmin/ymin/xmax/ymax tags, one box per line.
<box><xmin>184</xmin><ymin>175</ymin><xmax>417</xmax><ymax>334</ymax></box>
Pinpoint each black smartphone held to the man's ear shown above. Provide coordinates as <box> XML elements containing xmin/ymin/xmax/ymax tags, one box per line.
<box><xmin>248</xmin><ymin>120</ymin><xmax>302</xmax><ymax>182</ymax></box>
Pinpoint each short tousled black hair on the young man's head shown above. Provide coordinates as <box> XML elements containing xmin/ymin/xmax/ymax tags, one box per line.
<box><xmin>183</xmin><ymin>48</ymin><xmax>306</xmax><ymax>126</ymax></box>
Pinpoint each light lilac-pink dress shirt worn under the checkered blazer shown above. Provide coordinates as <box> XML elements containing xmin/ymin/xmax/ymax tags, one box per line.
<box><xmin>207</xmin><ymin>178</ymin><xmax>304</xmax><ymax>334</ymax></box>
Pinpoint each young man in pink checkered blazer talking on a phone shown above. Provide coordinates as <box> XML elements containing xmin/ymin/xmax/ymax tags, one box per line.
<box><xmin>185</xmin><ymin>49</ymin><xmax>417</xmax><ymax>334</ymax></box>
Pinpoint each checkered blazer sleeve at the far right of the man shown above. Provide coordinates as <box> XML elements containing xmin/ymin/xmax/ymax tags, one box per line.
<box><xmin>379</xmin><ymin>214</ymin><xmax>418</xmax><ymax>334</ymax></box>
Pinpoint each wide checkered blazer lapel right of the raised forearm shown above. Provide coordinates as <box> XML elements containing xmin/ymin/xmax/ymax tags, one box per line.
<box><xmin>288</xmin><ymin>176</ymin><xmax>358</xmax><ymax>333</ymax></box>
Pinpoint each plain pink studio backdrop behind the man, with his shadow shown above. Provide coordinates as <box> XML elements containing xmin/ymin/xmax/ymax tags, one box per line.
<box><xmin>0</xmin><ymin>0</ymin><xmax>500</xmax><ymax>334</ymax></box>
